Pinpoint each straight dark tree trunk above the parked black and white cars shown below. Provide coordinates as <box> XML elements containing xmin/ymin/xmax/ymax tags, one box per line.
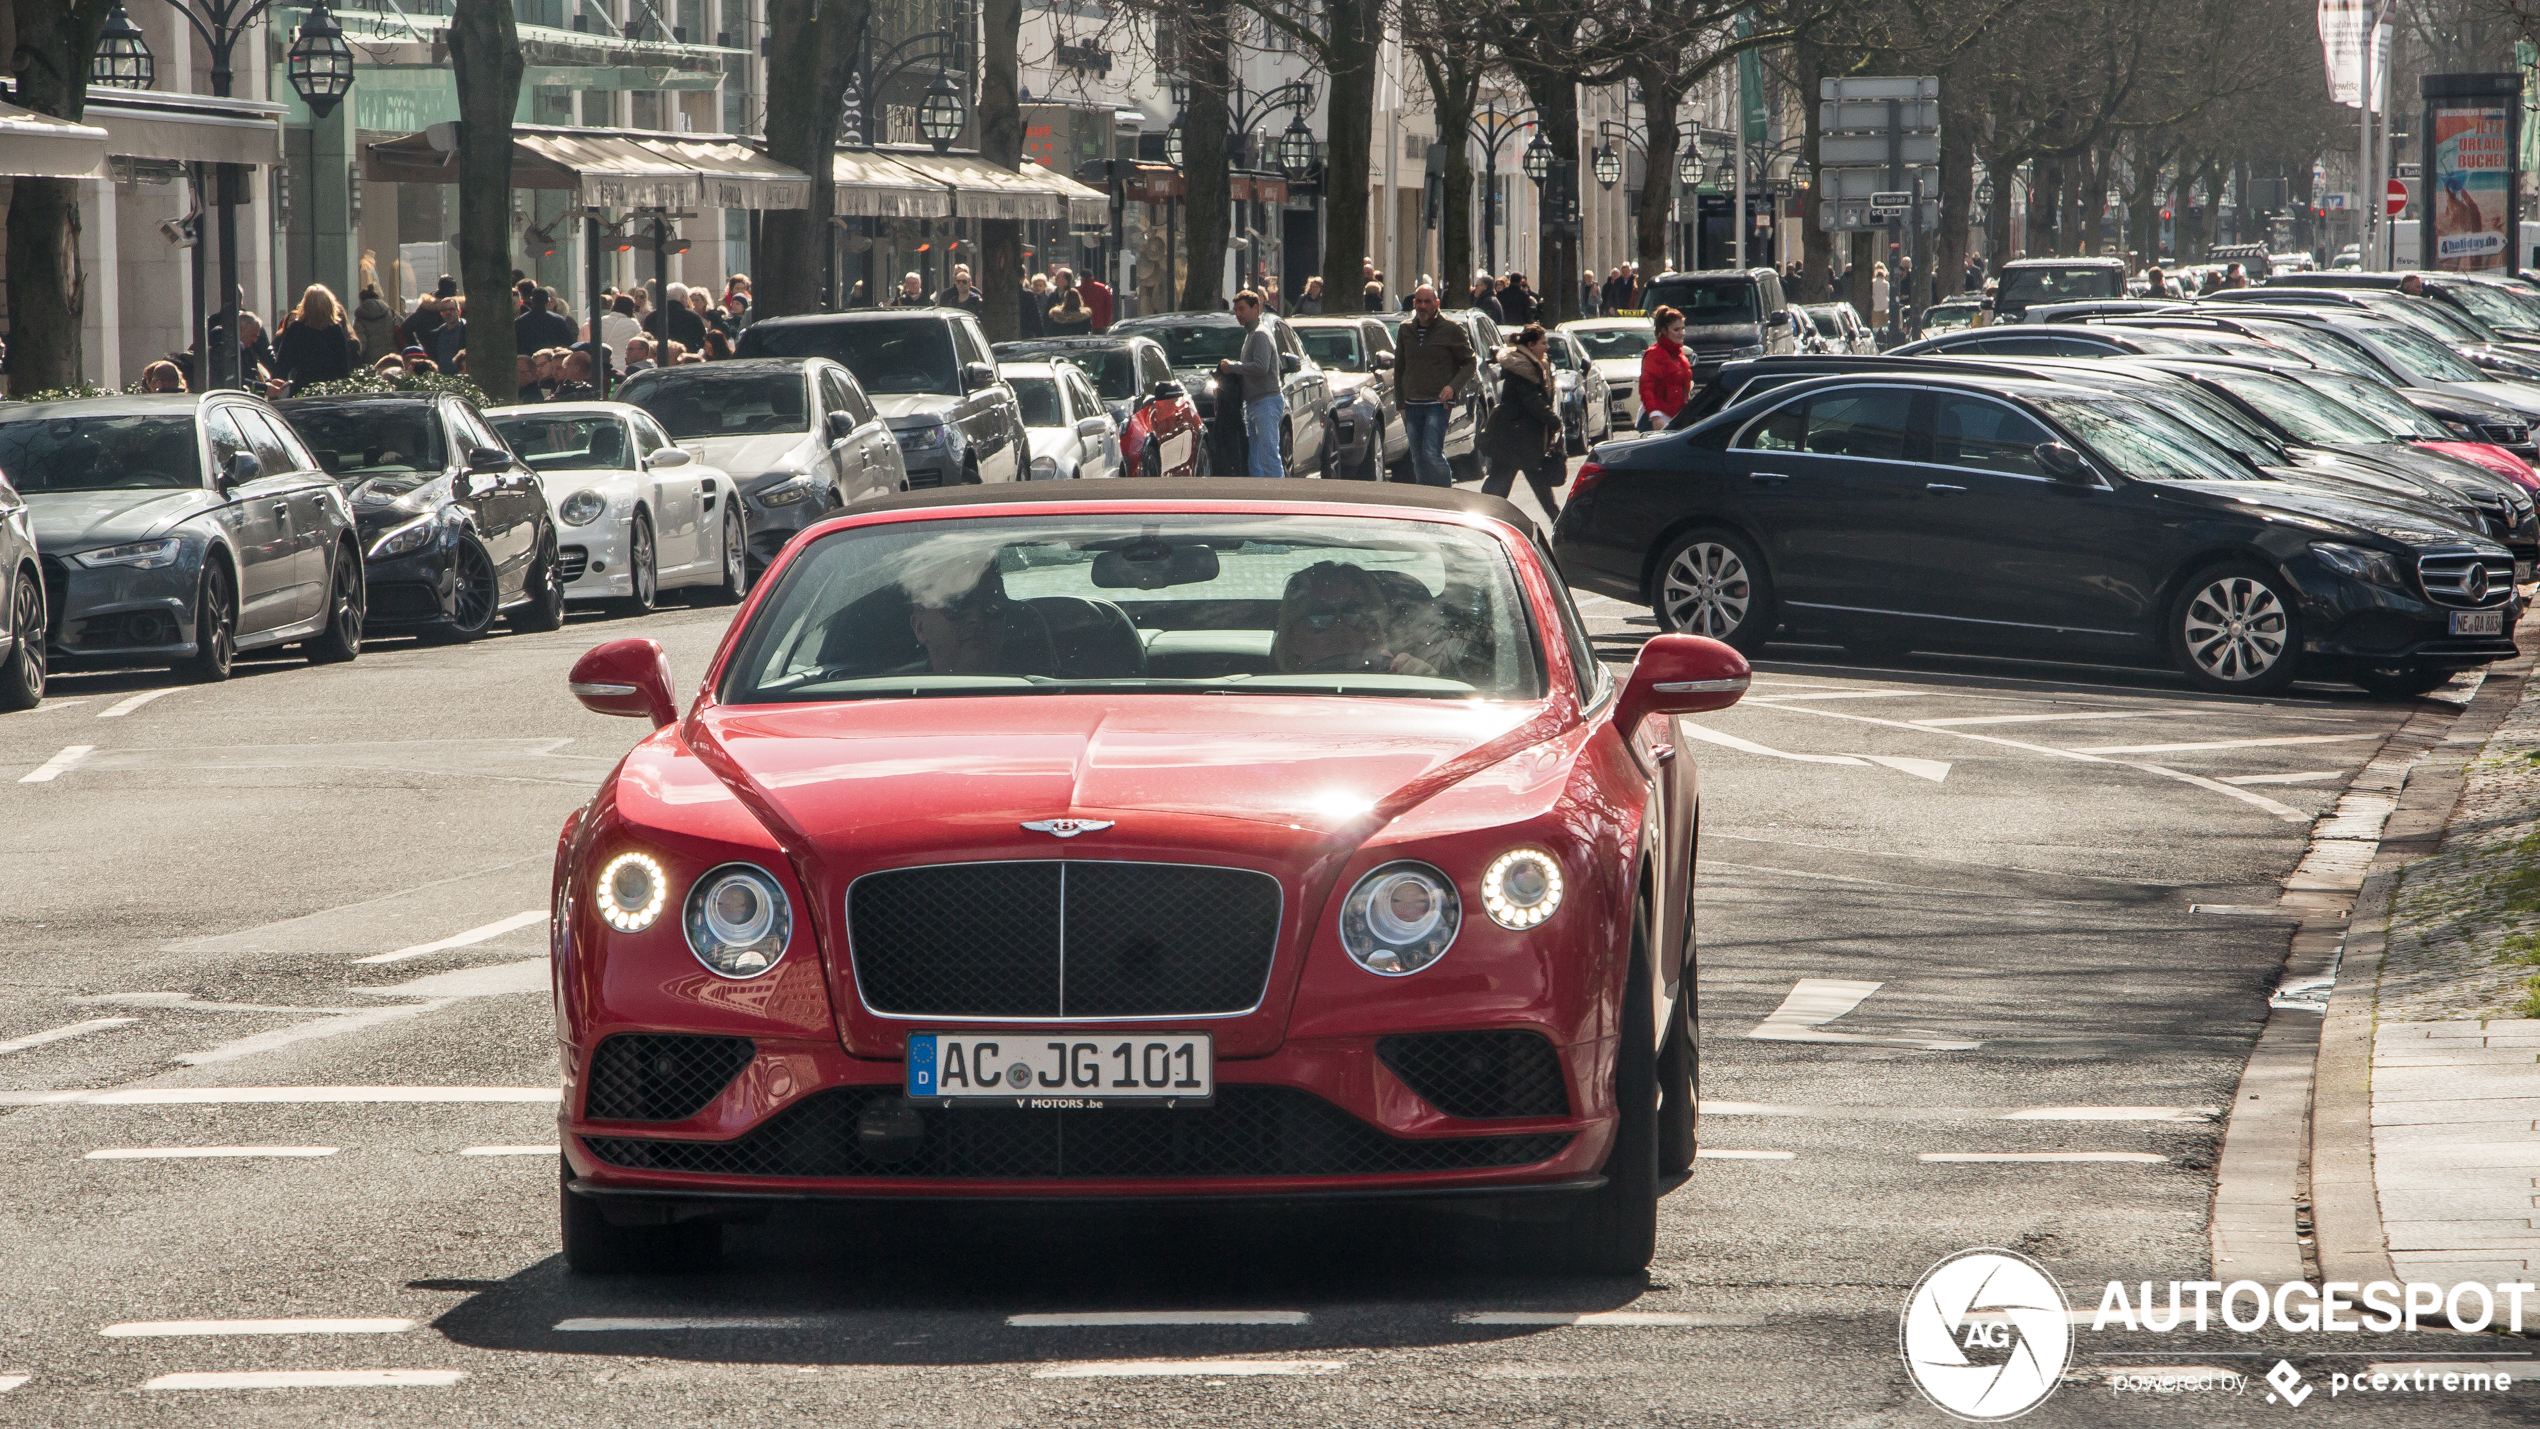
<box><xmin>450</xmin><ymin>0</ymin><xmax>521</xmax><ymax>406</ymax></box>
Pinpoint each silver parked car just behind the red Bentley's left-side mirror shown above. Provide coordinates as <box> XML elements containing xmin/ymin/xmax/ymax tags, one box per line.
<box><xmin>617</xmin><ymin>358</ymin><xmax>909</xmax><ymax>581</ymax></box>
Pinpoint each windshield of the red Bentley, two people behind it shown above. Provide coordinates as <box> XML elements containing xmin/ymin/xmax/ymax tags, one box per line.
<box><xmin>721</xmin><ymin>513</ymin><xmax>1544</xmax><ymax>703</ymax></box>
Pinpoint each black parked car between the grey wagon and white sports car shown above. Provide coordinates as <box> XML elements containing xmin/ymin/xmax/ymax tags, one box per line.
<box><xmin>277</xmin><ymin>393</ymin><xmax>564</xmax><ymax>642</ymax></box>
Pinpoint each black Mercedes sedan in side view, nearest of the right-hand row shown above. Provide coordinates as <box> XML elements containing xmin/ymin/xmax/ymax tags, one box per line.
<box><xmin>1554</xmin><ymin>373</ymin><xmax>2520</xmax><ymax>693</ymax></box>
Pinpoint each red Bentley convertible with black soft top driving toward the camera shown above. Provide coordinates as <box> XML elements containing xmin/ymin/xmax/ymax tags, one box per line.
<box><xmin>554</xmin><ymin>477</ymin><xmax>1748</xmax><ymax>1272</ymax></box>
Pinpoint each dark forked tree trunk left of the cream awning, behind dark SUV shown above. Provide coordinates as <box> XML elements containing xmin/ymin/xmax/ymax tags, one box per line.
<box><xmin>752</xmin><ymin>0</ymin><xmax>868</xmax><ymax>317</ymax></box>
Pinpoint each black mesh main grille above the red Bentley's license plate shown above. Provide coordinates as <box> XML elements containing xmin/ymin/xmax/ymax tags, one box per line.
<box><xmin>848</xmin><ymin>860</ymin><xmax>1280</xmax><ymax>1018</ymax></box>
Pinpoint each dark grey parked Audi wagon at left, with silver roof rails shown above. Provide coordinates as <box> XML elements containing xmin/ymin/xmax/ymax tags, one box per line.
<box><xmin>0</xmin><ymin>391</ymin><xmax>363</xmax><ymax>680</ymax></box>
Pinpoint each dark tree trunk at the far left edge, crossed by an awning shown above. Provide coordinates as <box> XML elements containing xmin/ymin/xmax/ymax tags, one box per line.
<box><xmin>8</xmin><ymin>0</ymin><xmax>117</xmax><ymax>396</ymax></box>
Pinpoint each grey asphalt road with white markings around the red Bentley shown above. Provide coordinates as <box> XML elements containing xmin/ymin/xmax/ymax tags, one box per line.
<box><xmin>0</xmin><ymin>474</ymin><xmax>2540</xmax><ymax>1426</ymax></box>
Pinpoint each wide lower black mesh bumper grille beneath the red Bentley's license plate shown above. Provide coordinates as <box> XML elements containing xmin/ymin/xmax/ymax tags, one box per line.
<box><xmin>584</xmin><ymin>1086</ymin><xmax>1570</xmax><ymax>1180</ymax></box>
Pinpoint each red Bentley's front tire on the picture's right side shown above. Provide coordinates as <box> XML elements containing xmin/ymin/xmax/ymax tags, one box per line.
<box><xmin>1539</xmin><ymin>904</ymin><xmax>1659</xmax><ymax>1274</ymax></box>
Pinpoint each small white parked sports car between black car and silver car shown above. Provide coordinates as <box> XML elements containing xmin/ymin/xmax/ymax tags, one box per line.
<box><xmin>490</xmin><ymin>401</ymin><xmax>749</xmax><ymax>614</ymax></box>
